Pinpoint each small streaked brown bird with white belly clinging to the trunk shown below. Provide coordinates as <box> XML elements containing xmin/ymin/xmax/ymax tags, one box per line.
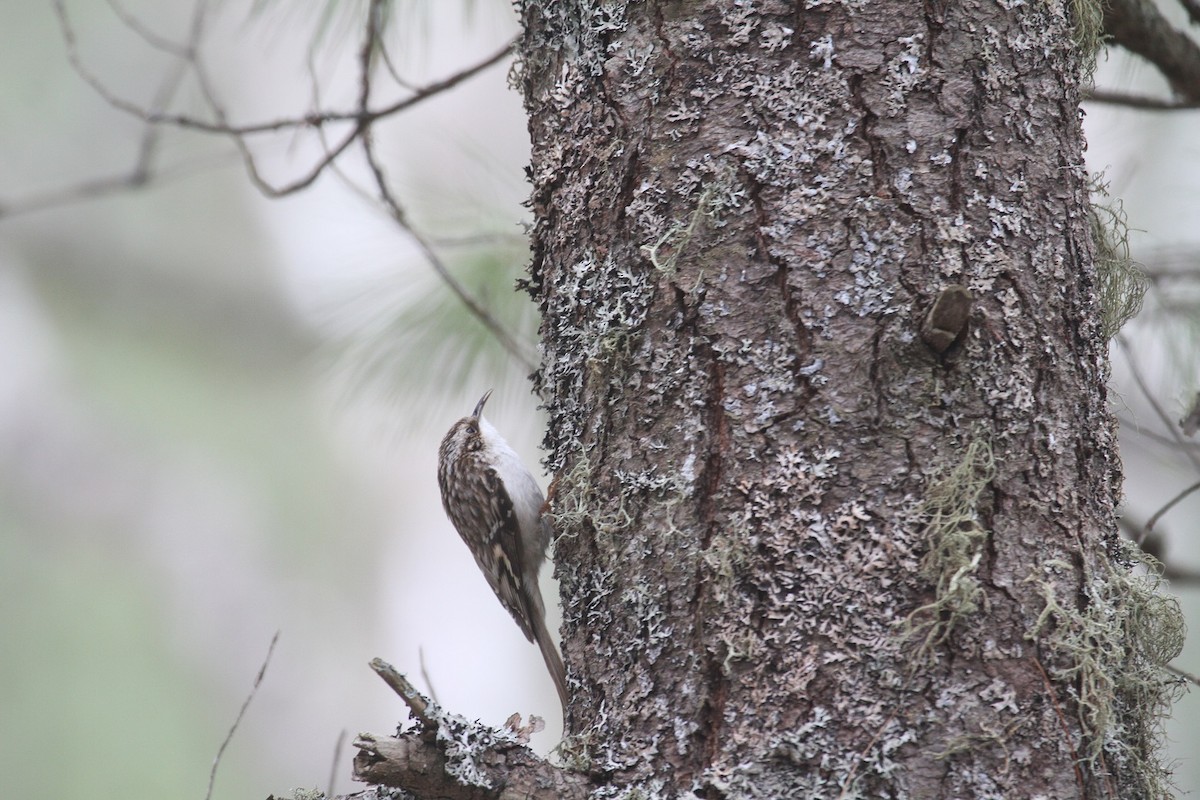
<box><xmin>438</xmin><ymin>390</ymin><xmax>566</xmax><ymax>709</ymax></box>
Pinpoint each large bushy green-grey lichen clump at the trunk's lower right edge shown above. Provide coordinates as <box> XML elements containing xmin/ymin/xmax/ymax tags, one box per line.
<box><xmin>1026</xmin><ymin>540</ymin><xmax>1186</xmax><ymax>798</ymax></box>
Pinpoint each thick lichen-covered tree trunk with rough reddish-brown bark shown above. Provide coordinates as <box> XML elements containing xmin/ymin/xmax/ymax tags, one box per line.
<box><xmin>518</xmin><ymin>0</ymin><xmax>1178</xmax><ymax>798</ymax></box>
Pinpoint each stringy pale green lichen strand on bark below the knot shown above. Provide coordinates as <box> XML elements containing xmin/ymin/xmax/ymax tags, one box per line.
<box><xmin>902</xmin><ymin>439</ymin><xmax>996</xmax><ymax>667</ymax></box>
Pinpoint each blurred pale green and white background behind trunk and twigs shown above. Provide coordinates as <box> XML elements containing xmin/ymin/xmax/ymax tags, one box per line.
<box><xmin>0</xmin><ymin>0</ymin><xmax>1200</xmax><ymax>800</ymax></box>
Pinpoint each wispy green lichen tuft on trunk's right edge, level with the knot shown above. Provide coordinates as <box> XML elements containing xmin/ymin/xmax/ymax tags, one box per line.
<box><xmin>1087</xmin><ymin>175</ymin><xmax>1150</xmax><ymax>339</ymax></box>
